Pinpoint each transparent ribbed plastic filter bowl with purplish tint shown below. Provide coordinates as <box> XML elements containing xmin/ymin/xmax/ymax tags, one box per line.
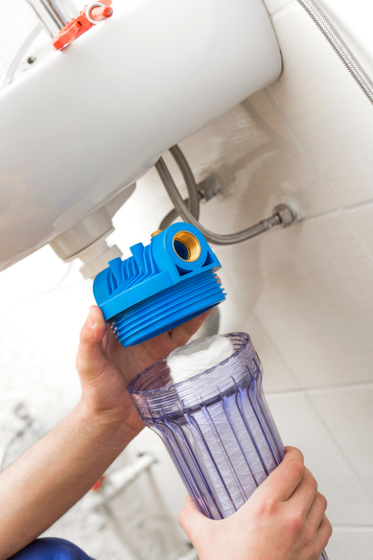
<box><xmin>128</xmin><ymin>333</ymin><xmax>327</xmax><ymax>560</ymax></box>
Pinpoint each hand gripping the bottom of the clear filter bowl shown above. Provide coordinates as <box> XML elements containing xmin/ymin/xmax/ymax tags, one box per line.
<box><xmin>179</xmin><ymin>447</ymin><xmax>332</xmax><ymax>560</ymax></box>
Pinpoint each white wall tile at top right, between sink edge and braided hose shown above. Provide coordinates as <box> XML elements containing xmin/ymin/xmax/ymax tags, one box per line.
<box><xmin>270</xmin><ymin>2</ymin><xmax>373</xmax><ymax>207</ymax></box>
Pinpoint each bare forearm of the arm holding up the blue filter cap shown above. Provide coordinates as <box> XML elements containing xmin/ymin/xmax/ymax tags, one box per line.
<box><xmin>0</xmin><ymin>403</ymin><xmax>133</xmax><ymax>560</ymax></box>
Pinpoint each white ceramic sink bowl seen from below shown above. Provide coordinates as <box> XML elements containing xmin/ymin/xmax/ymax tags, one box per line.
<box><xmin>0</xmin><ymin>0</ymin><xmax>281</xmax><ymax>270</ymax></box>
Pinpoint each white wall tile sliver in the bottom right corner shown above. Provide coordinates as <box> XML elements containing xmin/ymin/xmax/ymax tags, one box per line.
<box><xmin>327</xmin><ymin>527</ymin><xmax>373</xmax><ymax>560</ymax></box>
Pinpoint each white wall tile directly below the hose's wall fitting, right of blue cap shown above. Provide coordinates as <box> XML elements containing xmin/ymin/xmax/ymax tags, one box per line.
<box><xmin>214</xmin><ymin>213</ymin><xmax>373</xmax><ymax>387</ymax></box>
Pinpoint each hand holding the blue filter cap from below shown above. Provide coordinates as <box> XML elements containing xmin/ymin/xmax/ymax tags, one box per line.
<box><xmin>76</xmin><ymin>305</ymin><xmax>210</xmax><ymax>438</ymax></box>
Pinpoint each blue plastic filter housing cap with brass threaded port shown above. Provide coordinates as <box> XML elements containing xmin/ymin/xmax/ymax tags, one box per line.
<box><xmin>93</xmin><ymin>223</ymin><xmax>226</xmax><ymax>347</ymax></box>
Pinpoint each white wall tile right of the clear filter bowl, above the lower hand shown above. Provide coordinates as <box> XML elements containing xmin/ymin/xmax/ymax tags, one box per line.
<box><xmin>267</xmin><ymin>393</ymin><xmax>373</xmax><ymax>528</ymax></box>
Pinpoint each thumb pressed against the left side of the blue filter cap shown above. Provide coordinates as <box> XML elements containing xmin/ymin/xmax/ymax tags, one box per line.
<box><xmin>76</xmin><ymin>305</ymin><xmax>107</xmax><ymax>380</ymax></box>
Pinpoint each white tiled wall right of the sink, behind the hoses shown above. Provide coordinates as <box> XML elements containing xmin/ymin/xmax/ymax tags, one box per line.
<box><xmin>114</xmin><ymin>0</ymin><xmax>373</xmax><ymax>560</ymax></box>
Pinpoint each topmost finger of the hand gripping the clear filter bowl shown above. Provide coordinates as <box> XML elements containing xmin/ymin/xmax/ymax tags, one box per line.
<box><xmin>254</xmin><ymin>447</ymin><xmax>305</xmax><ymax>502</ymax></box>
